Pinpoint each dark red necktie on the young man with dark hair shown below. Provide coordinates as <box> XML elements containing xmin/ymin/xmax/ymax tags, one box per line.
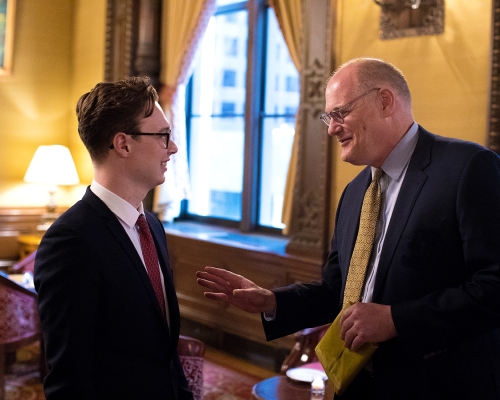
<box><xmin>137</xmin><ymin>214</ymin><xmax>166</xmax><ymax>316</ymax></box>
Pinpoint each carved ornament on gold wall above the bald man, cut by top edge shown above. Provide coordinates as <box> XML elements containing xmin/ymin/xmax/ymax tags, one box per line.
<box><xmin>374</xmin><ymin>0</ymin><xmax>445</xmax><ymax>40</ymax></box>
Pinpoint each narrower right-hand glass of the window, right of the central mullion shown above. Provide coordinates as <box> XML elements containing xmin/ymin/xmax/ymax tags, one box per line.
<box><xmin>259</xmin><ymin>8</ymin><xmax>300</xmax><ymax>228</ymax></box>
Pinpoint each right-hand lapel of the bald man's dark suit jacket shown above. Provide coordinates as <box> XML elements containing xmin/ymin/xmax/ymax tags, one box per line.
<box><xmin>373</xmin><ymin>127</ymin><xmax>434</xmax><ymax>301</ymax></box>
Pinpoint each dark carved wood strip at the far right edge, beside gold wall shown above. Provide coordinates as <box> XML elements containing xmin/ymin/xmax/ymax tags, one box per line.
<box><xmin>488</xmin><ymin>0</ymin><xmax>500</xmax><ymax>154</ymax></box>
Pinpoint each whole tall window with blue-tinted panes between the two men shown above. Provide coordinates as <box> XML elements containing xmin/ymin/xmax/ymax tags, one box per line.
<box><xmin>186</xmin><ymin>0</ymin><xmax>299</xmax><ymax>232</ymax></box>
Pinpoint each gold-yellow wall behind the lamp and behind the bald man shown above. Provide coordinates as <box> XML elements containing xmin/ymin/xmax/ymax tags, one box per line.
<box><xmin>0</xmin><ymin>0</ymin><xmax>491</xmax><ymax>218</ymax></box>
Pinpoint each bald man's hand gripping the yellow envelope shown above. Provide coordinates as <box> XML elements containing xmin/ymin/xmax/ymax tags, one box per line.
<box><xmin>340</xmin><ymin>303</ymin><xmax>397</xmax><ymax>351</ymax></box>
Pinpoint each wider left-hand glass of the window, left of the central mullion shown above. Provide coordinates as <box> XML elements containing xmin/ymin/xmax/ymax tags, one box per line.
<box><xmin>187</xmin><ymin>10</ymin><xmax>248</xmax><ymax>221</ymax></box>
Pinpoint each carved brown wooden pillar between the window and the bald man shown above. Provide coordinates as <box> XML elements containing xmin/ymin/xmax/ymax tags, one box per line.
<box><xmin>287</xmin><ymin>0</ymin><xmax>334</xmax><ymax>262</ymax></box>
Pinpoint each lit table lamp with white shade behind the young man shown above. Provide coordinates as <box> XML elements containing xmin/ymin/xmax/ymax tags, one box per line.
<box><xmin>24</xmin><ymin>144</ymin><xmax>80</xmax><ymax>230</ymax></box>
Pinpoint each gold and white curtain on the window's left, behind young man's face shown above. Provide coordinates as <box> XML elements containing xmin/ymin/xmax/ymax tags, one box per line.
<box><xmin>153</xmin><ymin>0</ymin><xmax>216</xmax><ymax>221</ymax></box>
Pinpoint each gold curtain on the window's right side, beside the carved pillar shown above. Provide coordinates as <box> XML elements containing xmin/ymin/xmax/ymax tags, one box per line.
<box><xmin>269</xmin><ymin>0</ymin><xmax>303</xmax><ymax>234</ymax></box>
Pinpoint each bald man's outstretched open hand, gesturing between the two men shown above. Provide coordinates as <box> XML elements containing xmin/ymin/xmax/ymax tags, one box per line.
<box><xmin>196</xmin><ymin>267</ymin><xmax>276</xmax><ymax>314</ymax></box>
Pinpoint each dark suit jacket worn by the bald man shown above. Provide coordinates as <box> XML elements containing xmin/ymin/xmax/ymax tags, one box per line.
<box><xmin>264</xmin><ymin>127</ymin><xmax>500</xmax><ymax>400</ymax></box>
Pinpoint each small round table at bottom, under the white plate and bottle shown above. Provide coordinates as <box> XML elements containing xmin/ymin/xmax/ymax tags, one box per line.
<box><xmin>252</xmin><ymin>375</ymin><xmax>334</xmax><ymax>400</ymax></box>
